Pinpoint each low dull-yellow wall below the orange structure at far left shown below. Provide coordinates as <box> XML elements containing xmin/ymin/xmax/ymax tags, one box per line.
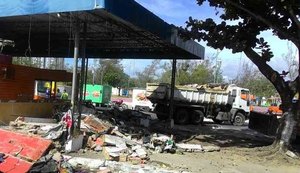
<box><xmin>0</xmin><ymin>102</ymin><xmax>53</xmax><ymax>125</ymax></box>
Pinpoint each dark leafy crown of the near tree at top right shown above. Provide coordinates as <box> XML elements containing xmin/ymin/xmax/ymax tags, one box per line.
<box><xmin>186</xmin><ymin>0</ymin><xmax>300</xmax><ymax>53</ymax></box>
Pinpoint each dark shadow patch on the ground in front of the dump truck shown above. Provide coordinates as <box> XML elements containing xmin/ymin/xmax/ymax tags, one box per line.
<box><xmin>151</xmin><ymin>122</ymin><xmax>273</xmax><ymax>148</ymax></box>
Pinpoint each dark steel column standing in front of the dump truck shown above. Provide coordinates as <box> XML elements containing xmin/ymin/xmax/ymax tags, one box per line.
<box><xmin>169</xmin><ymin>59</ymin><xmax>177</xmax><ymax>128</ymax></box>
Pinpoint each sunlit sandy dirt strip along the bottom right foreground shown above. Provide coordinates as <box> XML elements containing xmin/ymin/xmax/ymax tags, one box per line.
<box><xmin>150</xmin><ymin>148</ymin><xmax>300</xmax><ymax>173</ymax></box>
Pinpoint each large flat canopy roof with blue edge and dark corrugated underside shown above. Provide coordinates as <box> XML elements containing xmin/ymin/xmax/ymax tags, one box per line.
<box><xmin>0</xmin><ymin>0</ymin><xmax>204</xmax><ymax>59</ymax></box>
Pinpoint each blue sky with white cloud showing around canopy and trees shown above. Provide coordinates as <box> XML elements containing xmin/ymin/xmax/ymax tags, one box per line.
<box><xmin>123</xmin><ymin>0</ymin><xmax>298</xmax><ymax>79</ymax></box>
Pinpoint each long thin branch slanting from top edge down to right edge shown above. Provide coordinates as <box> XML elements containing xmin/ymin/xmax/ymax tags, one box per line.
<box><xmin>224</xmin><ymin>0</ymin><xmax>298</xmax><ymax>45</ymax></box>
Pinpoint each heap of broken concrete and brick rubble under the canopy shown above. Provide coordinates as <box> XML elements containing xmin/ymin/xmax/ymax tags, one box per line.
<box><xmin>0</xmin><ymin>108</ymin><xmax>218</xmax><ymax>173</ymax></box>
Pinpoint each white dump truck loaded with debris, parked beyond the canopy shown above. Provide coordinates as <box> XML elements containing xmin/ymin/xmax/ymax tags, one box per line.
<box><xmin>146</xmin><ymin>83</ymin><xmax>250</xmax><ymax>125</ymax></box>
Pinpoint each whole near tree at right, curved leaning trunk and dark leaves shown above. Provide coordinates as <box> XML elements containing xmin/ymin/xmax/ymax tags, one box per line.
<box><xmin>181</xmin><ymin>0</ymin><xmax>300</xmax><ymax>151</ymax></box>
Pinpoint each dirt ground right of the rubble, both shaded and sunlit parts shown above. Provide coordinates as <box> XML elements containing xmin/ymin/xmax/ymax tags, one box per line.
<box><xmin>150</xmin><ymin>122</ymin><xmax>300</xmax><ymax>173</ymax></box>
